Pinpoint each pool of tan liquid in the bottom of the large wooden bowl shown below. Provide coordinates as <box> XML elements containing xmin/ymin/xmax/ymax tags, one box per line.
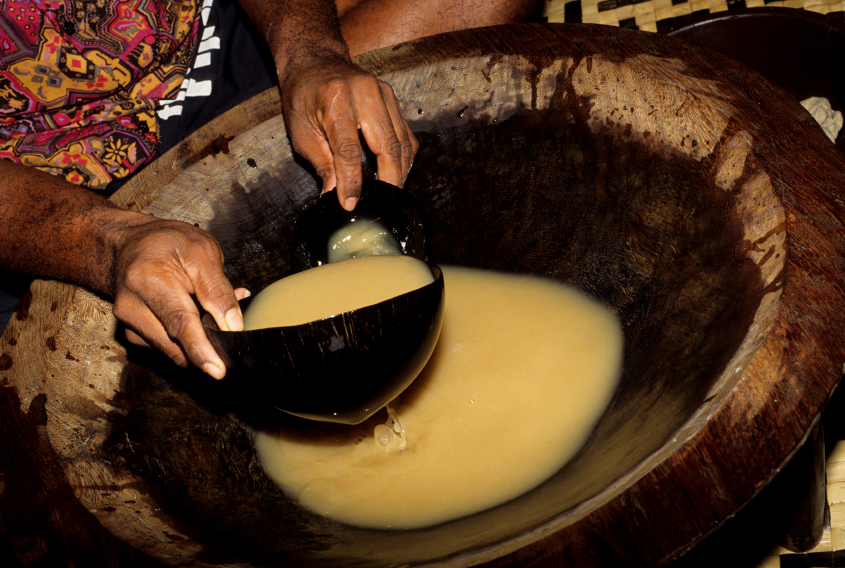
<box><xmin>255</xmin><ymin>267</ymin><xmax>622</xmax><ymax>528</ymax></box>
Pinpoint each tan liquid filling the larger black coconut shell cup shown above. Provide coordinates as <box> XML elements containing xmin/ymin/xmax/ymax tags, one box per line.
<box><xmin>244</xmin><ymin>255</ymin><xmax>434</xmax><ymax>330</ymax></box>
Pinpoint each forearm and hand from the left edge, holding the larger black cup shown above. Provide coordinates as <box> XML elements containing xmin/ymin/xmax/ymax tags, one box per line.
<box><xmin>0</xmin><ymin>160</ymin><xmax>244</xmax><ymax>378</ymax></box>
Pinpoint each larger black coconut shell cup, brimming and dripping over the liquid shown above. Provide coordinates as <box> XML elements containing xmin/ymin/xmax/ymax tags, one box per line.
<box><xmin>203</xmin><ymin>266</ymin><xmax>443</xmax><ymax>424</ymax></box>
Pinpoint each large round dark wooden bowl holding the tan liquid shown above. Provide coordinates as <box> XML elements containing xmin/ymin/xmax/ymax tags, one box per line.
<box><xmin>0</xmin><ymin>25</ymin><xmax>845</xmax><ymax>567</ymax></box>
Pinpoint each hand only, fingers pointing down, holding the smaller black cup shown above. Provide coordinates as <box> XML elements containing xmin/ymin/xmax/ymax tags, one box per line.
<box><xmin>281</xmin><ymin>55</ymin><xmax>419</xmax><ymax>211</ymax></box>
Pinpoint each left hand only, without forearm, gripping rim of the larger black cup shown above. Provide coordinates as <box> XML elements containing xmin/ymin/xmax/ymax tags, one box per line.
<box><xmin>113</xmin><ymin>218</ymin><xmax>249</xmax><ymax>379</ymax></box>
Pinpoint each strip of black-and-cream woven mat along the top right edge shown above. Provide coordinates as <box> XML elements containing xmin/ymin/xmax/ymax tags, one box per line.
<box><xmin>544</xmin><ymin>0</ymin><xmax>845</xmax><ymax>32</ymax></box>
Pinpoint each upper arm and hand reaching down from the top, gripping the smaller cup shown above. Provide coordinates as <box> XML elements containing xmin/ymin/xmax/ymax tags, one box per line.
<box><xmin>240</xmin><ymin>0</ymin><xmax>418</xmax><ymax>210</ymax></box>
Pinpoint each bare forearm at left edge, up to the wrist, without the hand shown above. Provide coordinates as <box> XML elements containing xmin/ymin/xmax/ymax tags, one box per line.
<box><xmin>0</xmin><ymin>160</ymin><xmax>152</xmax><ymax>295</ymax></box>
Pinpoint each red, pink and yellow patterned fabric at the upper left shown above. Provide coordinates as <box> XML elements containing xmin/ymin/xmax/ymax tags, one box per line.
<box><xmin>0</xmin><ymin>0</ymin><xmax>200</xmax><ymax>189</ymax></box>
